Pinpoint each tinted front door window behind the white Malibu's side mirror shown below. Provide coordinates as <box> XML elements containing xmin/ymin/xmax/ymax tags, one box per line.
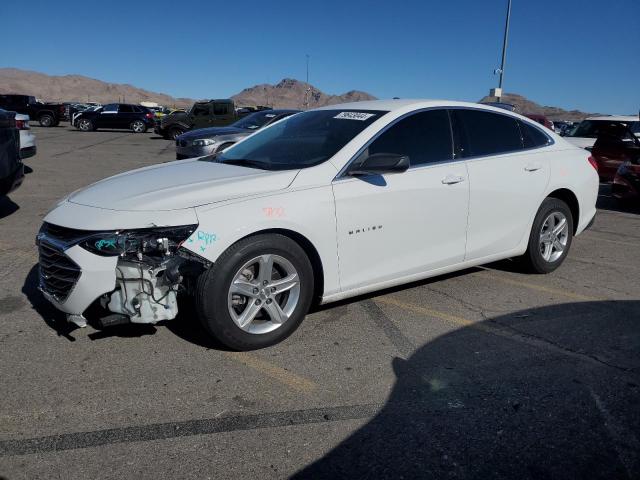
<box><xmin>363</xmin><ymin>110</ymin><xmax>453</xmax><ymax>166</ymax></box>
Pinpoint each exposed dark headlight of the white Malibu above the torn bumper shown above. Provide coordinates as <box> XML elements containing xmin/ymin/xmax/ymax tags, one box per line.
<box><xmin>80</xmin><ymin>225</ymin><xmax>198</xmax><ymax>258</ymax></box>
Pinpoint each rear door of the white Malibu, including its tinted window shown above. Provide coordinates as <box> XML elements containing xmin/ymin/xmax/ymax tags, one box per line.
<box><xmin>451</xmin><ymin>109</ymin><xmax>551</xmax><ymax>260</ymax></box>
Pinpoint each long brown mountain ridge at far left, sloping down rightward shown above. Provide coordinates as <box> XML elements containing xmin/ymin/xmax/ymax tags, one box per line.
<box><xmin>0</xmin><ymin>68</ymin><xmax>193</xmax><ymax>107</ymax></box>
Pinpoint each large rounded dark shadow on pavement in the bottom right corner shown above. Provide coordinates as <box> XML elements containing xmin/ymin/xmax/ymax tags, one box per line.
<box><xmin>293</xmin><ymin>301</ymin><xmax>640</xmax><ymax>480</ymax></box>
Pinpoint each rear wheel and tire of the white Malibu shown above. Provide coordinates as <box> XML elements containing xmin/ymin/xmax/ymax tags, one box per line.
<box><xmin>521</xmin><ymin>197</ymin><xmax>573</xmax><ymax>273</ymax></box>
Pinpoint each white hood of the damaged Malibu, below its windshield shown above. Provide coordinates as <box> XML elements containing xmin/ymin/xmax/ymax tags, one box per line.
<box><xmin>68</xmin><ymin>160</ymin><xmax>298</xmax><ymax>211</ymax></box>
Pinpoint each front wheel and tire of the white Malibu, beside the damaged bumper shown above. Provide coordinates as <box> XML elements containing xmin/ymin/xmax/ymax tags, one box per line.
<box><xmin>195</xmin><ymin>234</ymin><xmax>313</xmax><ymax>350</ymax></box>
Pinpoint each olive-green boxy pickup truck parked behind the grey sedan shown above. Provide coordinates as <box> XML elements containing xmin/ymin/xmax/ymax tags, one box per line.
<box><xmin>154</xmin><ymin>99</ymin><xmax>239</xmax><ymax>140</ymax></box>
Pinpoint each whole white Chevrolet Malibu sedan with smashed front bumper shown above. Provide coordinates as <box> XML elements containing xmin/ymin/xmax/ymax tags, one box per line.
<box><xmin>36</xmin><ymin>100</ymin><xmax>598</xmax><ymax>350</ymax></box>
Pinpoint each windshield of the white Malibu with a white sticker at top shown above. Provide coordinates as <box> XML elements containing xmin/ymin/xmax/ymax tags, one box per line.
<box><xmin>203</xmin><ymin>110</ymin><xmax>387</xmax><ymax>170</ymax></box>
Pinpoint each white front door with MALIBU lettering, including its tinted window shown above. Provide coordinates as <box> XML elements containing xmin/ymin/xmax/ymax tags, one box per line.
<box><xmin>333</xmin><ymin>110</ymin><xmax>469</xmax><ymax>291</ymax></box>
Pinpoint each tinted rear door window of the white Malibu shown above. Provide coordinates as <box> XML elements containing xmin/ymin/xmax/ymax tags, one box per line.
<box><xmin>452</xmin><ymin>109</ymin><xmax>522</xmax><ymax>157</ymax></box>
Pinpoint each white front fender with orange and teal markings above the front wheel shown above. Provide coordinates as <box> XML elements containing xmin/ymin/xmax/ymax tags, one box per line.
<box><xmin>183</xmin><ymin>186</ymin><xmax>340</xmax><ymax>296</ymax></box>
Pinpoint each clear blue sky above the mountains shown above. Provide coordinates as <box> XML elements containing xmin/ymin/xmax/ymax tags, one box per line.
<box><xmin>0</xmin><ymin>0</ymin><xmax>640</xmax><ymax>114</ymax></box>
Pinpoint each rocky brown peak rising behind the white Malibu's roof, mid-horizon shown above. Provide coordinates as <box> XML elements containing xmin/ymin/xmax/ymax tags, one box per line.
<box><xmin>231</xmin><ymin>78</ymin><xmax>376</xmax><ymax>108</ymax></box>
